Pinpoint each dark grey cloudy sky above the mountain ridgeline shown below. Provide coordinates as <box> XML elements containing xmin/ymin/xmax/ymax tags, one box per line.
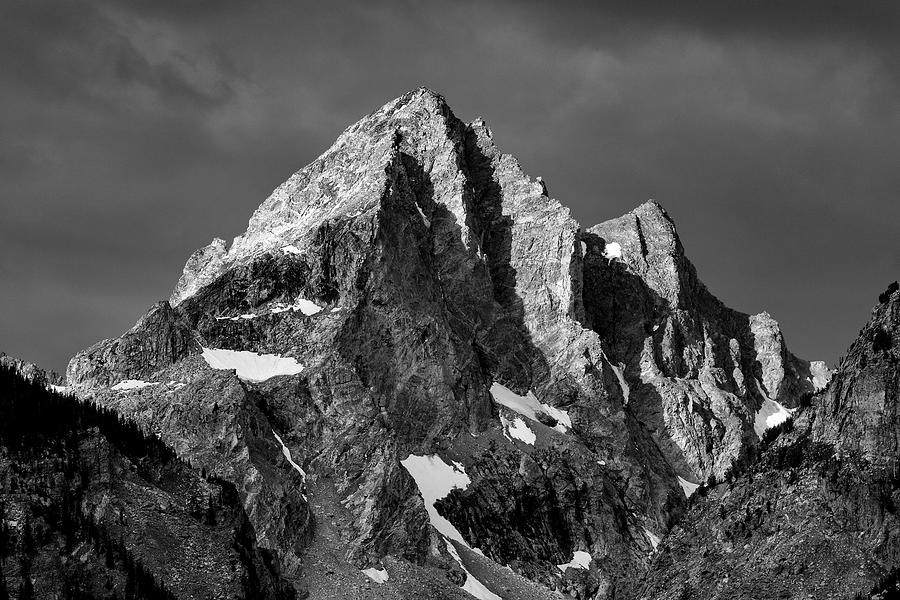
<box><xmin>0</xmin><ymin>0</ymin><xmax>900</xmax><ymax>370</ymax></box>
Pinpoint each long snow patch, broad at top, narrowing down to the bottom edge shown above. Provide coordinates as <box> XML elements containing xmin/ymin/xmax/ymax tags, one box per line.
<box><xmin>400</xmin><ymin>454</ymin><xmax>503</xmax><ymax>600</ymax></box>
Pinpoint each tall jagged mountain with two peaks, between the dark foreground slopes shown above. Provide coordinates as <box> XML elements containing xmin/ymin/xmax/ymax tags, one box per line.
<box><xmin>19</xmin><ymin>88</ymin><xmax>844</xmax><ymax>599</ymax></box>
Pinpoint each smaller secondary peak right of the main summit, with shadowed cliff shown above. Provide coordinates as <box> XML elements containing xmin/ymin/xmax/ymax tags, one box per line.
<box><xmin>584</xmin><ymin>201</ymin><xmax>828</xmax><ymax>481</ymax></box>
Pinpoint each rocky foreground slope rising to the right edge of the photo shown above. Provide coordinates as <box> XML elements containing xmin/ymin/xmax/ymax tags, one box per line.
<box><xmin>631</xmin><ymin>288</ymin><xmax>900</xmax><ymax>598</ymax></box>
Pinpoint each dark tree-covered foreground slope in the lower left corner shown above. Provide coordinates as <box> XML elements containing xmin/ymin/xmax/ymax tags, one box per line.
<box><xmin>0</xmin><ymin>365</ymin><xmax>293</xmax><ymax>600</ymax></box>
